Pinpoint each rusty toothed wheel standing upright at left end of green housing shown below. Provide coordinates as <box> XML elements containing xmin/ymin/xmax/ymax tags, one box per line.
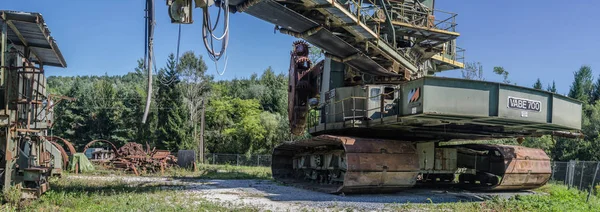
<box><xmin>288</xmin><ymin>41</ymin><xmax>322</xmax><ymax>135</ymax></box>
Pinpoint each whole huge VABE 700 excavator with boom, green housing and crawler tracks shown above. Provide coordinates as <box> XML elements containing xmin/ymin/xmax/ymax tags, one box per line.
<box><xmin>158</xmin><ymin>0</ymin><xmax>581</xmax><ymax>193</ymax></box>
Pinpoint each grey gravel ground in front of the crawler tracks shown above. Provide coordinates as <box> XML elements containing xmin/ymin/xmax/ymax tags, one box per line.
<box><xmin>69</xmin><ymin>176</ymin><xmax>532</xmax><ymax>211</ymax></box>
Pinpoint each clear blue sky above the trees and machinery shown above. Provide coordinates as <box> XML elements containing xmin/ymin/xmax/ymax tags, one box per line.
<box><xmin>0</xmin><ymin>0</ymin><xmax>600</xmax><ymax>94</ymax></box>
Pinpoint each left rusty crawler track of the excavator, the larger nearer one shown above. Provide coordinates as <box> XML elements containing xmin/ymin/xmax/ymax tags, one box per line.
<box><xmin>272</xmin><ymin>135</ymin><xmax>419</xmax><ymax>193</ymax></box>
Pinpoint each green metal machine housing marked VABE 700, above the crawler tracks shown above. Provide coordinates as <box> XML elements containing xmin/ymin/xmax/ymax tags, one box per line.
<box><xmin>308</xmin><ymin>76</ymin><xmax>582</xmax><ymax>140</ymax></box>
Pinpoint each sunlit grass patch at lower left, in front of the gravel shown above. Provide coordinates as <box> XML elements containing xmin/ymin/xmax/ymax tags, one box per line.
<box><xmin>11</xmin><ymin>178</ymin><xmax>257</xmax><ymax>211</ymax></box>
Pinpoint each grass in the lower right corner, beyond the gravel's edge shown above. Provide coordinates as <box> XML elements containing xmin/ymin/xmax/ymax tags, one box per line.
<box><xmin>389</xmin><ymin>184</ymin><xmax>600</xmax><ymax>212</ymax></box>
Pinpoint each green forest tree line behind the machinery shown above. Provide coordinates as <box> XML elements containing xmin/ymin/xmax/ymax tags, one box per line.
<box><xmin>48</xmin><ymin>51</ymin><xmax>600</xmax><ymax>161</ymax></box>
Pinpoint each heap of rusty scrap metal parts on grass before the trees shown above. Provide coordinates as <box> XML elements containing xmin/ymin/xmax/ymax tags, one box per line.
<box><xmin>84</xmin><ymin>140</ymin><xmax>177</xmax><ymax>175</ymax></box>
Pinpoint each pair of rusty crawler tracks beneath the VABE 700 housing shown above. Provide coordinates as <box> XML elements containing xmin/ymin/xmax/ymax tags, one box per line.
<box><xmin>271</xmin><ymin>135</ymin><xmax>551</xmax><ymax>193</ymax></box>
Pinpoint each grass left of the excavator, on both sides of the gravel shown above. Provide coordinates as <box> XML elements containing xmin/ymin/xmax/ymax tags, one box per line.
<box><xmin>0</xmin><ymin>165</ymin><xmax>271</xmax><ymax>211</ymax></box>
